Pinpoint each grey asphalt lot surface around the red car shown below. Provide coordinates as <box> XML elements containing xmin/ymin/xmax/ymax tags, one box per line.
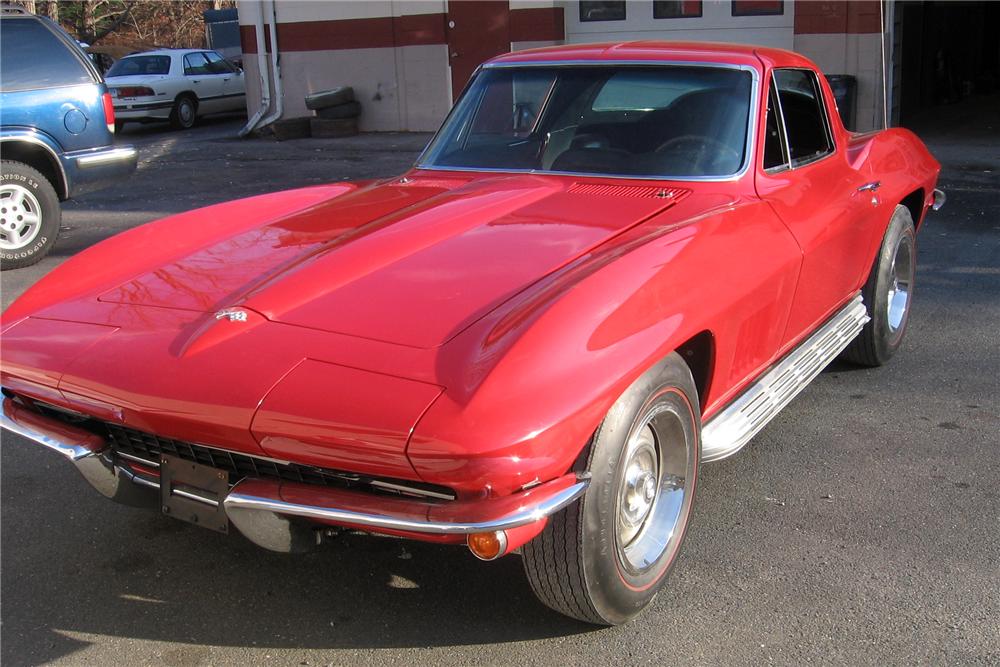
<box><xmin>0</xmin><ymin>104</ymin><xmax>1000</xmax><ymax>666</ymax></box>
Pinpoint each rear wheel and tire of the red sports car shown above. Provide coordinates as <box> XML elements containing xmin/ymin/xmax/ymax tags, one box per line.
<box><xmin>841</xmin><ymin>206</ymin><xmax>917</xmax><ymax>366</ymax></box>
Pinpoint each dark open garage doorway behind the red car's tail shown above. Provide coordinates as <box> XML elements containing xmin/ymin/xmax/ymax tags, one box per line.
<box><xmin>893</xmin><ymin>1</ymin><xmax>1000</xmax><ymax>126</ymax></box>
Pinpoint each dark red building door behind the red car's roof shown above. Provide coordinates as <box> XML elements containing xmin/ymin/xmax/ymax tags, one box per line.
<box><xmin>448</xmin><ymin>0</ymin><xmax>510</xmax><ymax>102</ymax></box>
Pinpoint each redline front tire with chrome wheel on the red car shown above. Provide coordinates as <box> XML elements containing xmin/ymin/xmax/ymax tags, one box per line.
<box><xmin>523</xmin><ymin>354</ymin><xmax>701</xmax><ymax>625</ymax></box>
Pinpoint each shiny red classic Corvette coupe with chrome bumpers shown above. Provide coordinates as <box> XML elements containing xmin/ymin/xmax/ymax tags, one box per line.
<box><xmin>2</xmin><ymin>42</ymin><xmax>944</xmax><ymax>624</ymax></box>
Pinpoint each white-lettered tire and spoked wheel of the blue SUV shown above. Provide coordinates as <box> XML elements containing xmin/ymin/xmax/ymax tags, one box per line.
<box><xmin>0</xmin><ymin>160</ymin><xmax>62</xmax><ymax>271</ymax></box>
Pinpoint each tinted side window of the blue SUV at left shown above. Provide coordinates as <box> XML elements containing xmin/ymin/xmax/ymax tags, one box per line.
<box><xmin>0</xmin><ymin>17</ymin><xmax>94</xmax><ymax>92</ymax></box>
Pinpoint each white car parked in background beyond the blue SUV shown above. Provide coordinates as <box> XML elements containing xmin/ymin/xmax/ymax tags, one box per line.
<box><xmin>104</xmin><ymin>49</ymin><xmax>246</xmax><ymax>129</ymax></box>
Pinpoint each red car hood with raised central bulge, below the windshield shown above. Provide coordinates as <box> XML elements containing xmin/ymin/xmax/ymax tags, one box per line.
<box><xmin>99</xmin><ymin>175</ymin><xmax>674</xmax><ymax>348</ymax></box>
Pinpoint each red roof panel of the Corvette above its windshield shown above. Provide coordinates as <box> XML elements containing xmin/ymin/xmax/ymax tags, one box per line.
<box><xmin>489</xmin><ymin>40</ymin><xmax>812</xmax><ymax>68</ymax></box>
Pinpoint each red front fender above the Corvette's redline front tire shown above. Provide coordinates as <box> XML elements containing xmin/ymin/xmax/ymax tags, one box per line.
<box><xmin>407</xmin><ymin>197</ymin><xmax>801</xmax><ymax>494</ymax></box>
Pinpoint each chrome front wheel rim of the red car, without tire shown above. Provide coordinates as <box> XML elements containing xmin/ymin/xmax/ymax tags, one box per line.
<box><xmin>615</xmin><ymin>405</ymin><xmax>693</xmax><ymax>575</ymax></box>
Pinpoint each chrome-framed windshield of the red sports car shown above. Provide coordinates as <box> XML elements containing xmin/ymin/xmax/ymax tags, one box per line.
<box><xmin>418</xmin><ymin>65</ymin><xmax>752</xmax><ymax>178</ymax></box>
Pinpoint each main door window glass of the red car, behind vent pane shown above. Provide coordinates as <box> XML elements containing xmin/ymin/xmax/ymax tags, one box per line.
<box><xmin>774</xmin><ymin>69</ymin><xmax>833</xmax><ymax>167</ymax></box>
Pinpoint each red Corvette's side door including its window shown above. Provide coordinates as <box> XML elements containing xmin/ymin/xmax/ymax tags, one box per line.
<box><xmin>757</xmin><ymin>69</ymin><xmax>875</xmax><ymax>343</ymax></box>
